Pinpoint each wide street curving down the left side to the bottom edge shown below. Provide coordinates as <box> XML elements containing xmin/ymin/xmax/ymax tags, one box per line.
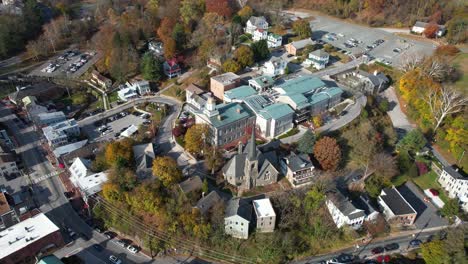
<box><xmin>0</xmin><ymin>102</ymin><xmax>199</xmax><ymax>263</ymax></box>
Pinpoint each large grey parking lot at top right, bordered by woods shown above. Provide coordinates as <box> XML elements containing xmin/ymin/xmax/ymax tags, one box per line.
<box><xmin>310</xmin><ymin>16</ymin><xmax>435</xmax><ymax>67</ymax></box>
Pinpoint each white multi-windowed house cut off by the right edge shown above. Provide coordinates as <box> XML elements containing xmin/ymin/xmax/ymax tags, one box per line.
<box><xmin>438</xmin><ymin>166</ymin><xmax>468</xmax><ymax>212</ymax></box>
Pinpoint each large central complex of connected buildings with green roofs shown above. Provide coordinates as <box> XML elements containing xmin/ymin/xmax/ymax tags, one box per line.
<box><xmin>186</xmin><ymin>72</ymin><xmax>343</xmax><ymax>146</ymax></box>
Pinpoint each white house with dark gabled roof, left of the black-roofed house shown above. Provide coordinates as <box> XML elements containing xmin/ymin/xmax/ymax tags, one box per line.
<box><xmin>325</xmin><ymin>191</ymin><xmax>366</xmax><ymax>229</ymax></box>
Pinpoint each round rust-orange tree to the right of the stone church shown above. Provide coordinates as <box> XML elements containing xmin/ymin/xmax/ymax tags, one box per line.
<box><xmin>314</xmin><ymin>137</ymin><xmax>341</xmax><ymax>170</ymax></box>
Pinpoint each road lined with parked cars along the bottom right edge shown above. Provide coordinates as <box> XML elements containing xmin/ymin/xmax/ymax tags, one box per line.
<box><xmin>292</xmin><ymin>230</ymin><xmax>446</xmax><ymax>264</ymax></box>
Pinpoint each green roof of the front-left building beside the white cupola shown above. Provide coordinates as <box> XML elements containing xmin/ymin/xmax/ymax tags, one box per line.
<box><xmin>210</xmin><ymin>103</ymin><xmax>253</xmax><ymax>127</ymax></box>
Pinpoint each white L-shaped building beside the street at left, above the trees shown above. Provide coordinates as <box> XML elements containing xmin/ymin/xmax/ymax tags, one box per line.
<box><xmin>69</xmin><ymin>158</ymin><xmax>107</xmax><ymax>202</ymax></box>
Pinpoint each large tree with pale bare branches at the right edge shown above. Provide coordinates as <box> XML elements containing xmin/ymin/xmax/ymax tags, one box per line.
<box><xmin>425</xmin><ymin>86</ymin><xmax>468</xmax><ymax>133</ymax></box>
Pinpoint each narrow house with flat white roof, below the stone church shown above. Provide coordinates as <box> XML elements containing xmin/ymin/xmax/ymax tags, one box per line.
<box><xmin>252</xmin><ymin>198</ymin><xmax>276</xmax><ymax>233</ymax></box>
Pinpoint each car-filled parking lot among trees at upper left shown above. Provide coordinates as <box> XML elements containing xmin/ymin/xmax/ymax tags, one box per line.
<box><xmin>30</xmin><ymin>50</ymin><xmax>99</xmax><ymax>78</ymax></box>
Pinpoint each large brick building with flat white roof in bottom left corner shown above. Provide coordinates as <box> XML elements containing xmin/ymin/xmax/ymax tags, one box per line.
<box><xmin>0</xmin><ymin>213</ymin><xmax>64</xmax><ymax>264</ymax></box>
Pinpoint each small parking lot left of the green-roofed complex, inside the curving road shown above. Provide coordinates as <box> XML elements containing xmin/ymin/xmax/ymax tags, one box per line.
<box><xmin>82</xmin><ymin>111</ymin><xmax>149</xmax><ymax>141</ymax></box>
